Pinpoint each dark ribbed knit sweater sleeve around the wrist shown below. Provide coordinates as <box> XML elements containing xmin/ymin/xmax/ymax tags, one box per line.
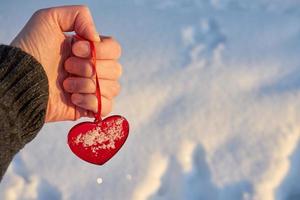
<box><xmin>0</xmin><ymin>45</ymin><xmax>49</xmax><ymax>181</ymax></box>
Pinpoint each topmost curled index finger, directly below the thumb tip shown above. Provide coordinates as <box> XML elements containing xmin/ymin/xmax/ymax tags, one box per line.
<box><xmin>72</xmin><ymin>37</ymin><xmax>122</xmax><ymax>60</ymax></box>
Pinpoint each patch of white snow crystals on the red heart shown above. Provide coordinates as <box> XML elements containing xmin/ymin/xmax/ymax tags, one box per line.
<box><xmin>74</xmin><ymin>118</ymin><xmax>124</xmax><ymax>154</ymax></box>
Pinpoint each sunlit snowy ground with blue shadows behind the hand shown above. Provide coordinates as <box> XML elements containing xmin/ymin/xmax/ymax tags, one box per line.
<box><xmin>0</xmin><ymin>0</ymin><xmax>300</xmax><ymax>200</ymax></box>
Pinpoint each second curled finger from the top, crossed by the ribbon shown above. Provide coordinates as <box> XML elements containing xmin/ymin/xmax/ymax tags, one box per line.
<box><xmin>65</xmin><ymin>57</ymin><xmax>122</xmax><ymax>80</ymax></box>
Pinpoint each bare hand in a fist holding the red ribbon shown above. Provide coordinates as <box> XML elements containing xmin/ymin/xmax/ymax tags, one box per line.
<box><xmin>11</xmin><ymin>6</ymin><xmax>121</xmax><ymax>122</ymax></box>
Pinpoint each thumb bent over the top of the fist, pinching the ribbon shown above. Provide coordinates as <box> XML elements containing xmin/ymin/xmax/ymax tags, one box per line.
<box><xmin>36</xmin><ymin>5</ymin><xmax>100</xmax><ymax>42</ymax></box>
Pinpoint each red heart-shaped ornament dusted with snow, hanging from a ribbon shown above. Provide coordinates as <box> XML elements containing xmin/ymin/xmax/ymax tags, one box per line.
<box><xmin>68</xmin><ymin>115</ymin><xmax>129</xmax><ymax>165</ymax></box>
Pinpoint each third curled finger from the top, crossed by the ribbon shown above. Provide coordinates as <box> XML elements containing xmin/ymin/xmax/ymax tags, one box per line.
<box><xmin>63</xmin><ymin>77</ymin><xmax>121</xmax><ymax>99</ymax></box>
